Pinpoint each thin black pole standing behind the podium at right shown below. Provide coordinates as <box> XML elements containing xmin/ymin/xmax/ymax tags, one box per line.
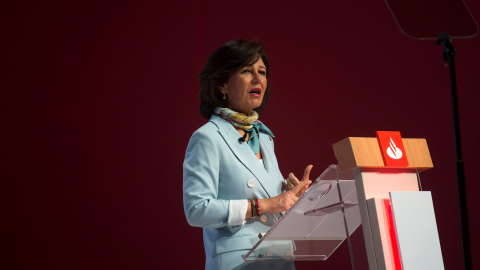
<box><xmin>437</xmin><ymin>34</ymin><xmax>472</xmax><ymax>270</ymax></box>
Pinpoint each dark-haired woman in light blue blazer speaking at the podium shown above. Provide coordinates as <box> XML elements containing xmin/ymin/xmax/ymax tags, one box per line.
<box><xmin>183</xmin><ymin>40</ymin><xmax>312</xmax><ymax>269</ymax></box>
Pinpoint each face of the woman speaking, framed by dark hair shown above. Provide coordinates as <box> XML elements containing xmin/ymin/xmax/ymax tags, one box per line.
<box><xmin>221</xmin><ymin>57</ymin><xmax>267</xmax><ymax>115</ymax></box>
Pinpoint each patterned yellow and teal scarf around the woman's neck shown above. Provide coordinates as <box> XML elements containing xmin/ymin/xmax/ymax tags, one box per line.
<box><xmin>215</xmin><ymin>107</ymin><xmax>275</xmax><ymax>153</ymax></box>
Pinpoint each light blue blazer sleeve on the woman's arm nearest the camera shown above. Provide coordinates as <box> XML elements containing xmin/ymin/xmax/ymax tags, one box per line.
<box><xmin>183</xmin><ymin>127</ymin><xmax>229</xmax><ymax>228</ymax></box>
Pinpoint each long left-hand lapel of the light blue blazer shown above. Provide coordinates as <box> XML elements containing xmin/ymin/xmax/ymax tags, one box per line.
<box><xmin>210</xmin><ymin>115</ymin><xmax>274</xmax><ymax>197</ymax></box>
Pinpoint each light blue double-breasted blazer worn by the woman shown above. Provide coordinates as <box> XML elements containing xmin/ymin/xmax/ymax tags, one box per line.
<box><xmin>183</xmin><ymin>115</ymin><xmax>293</xmax><ymax>269</ymax></box>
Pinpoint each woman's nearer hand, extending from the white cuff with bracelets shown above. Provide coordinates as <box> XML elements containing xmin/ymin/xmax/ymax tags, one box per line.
<box><xmin>258</xmin><ymin>179</ymin><xmax>312</xmax><ymax>214</ymax></box>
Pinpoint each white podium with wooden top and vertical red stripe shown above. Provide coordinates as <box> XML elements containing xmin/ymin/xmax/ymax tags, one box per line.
<box><xmin>333</xmin><ymin>136</ymin><xmax>444</xmax><ymax>270</ymax></box>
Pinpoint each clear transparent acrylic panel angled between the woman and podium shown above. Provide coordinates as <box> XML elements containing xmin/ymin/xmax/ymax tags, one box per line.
<box><xmin>243</xmin><ymin>165</ymin><xmax>361</xmax><ymax>261</ymax></box>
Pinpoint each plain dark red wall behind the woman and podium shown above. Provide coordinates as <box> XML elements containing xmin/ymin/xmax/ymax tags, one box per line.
<box><xmin>0</xmin><ymin>0</ymin><xmax>480</xmax><ymax>269</ymax></box>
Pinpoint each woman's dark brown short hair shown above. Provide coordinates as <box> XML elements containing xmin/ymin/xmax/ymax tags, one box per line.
<box><xmin>198</xmin><ymin>39</ymin><xmax>270</xmax><ymax>119</ymax></box>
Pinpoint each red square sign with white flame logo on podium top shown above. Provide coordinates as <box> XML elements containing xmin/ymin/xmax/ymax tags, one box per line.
<box><xmin>376</xmin><ymin>131</ymin><xmax>408</xmax><ymax>167</ymax></box>
